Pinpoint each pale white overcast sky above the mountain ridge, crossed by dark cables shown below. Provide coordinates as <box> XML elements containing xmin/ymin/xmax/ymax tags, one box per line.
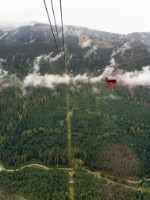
<box><xmin>0</xmin><ymin>0</ymin><xmax>150</xmax><ymax>34</ymax></box>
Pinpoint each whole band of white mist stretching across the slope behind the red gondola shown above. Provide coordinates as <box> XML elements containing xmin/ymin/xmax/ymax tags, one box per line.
<box><xmin>0</xmin><ymin>48</ymin><xmax>150</xmax><ymax>92</ymax></box>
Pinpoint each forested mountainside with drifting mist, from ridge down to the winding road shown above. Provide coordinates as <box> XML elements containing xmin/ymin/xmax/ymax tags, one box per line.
<box><xmin>0</xmin><ymin>24</ymin><xmax>150</xmax><ymax>199</ymax></box>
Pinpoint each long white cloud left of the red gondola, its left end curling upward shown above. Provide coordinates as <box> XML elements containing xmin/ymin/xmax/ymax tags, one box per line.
<box><xmin>23</xmin><ymin>55</ymin><xmax>114</xmax><ymax>88</ymax></box>
